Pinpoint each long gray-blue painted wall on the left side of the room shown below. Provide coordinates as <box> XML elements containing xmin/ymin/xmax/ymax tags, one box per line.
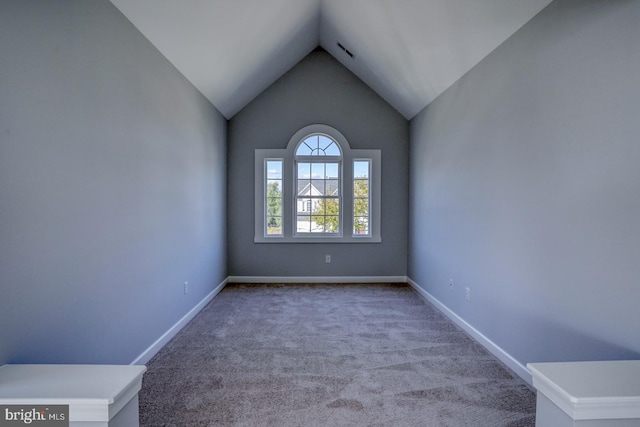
<box><xmin>0</xmin><ymin>0</ymin><xmax>227</xmax><ymax>364</ymax></box>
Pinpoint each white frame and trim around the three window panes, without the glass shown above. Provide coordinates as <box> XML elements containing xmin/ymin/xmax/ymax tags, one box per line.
<box><xmin>254</xmin><ymin>124</ymin><xmax>382</xmax><ymax>243</ymax></box>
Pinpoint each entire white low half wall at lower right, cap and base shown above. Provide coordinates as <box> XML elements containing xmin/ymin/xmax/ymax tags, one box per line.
<box><xmin>527</xmin><ymin>360</ymin><xmax>640</xmax><ymax>427</ymax></box>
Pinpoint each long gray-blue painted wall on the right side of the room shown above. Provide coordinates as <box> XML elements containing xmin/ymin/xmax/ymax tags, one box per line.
<box><xmin>408</xmin><ymin>0</ymin><xmax>640</xmax><ymax>364</ymax></box>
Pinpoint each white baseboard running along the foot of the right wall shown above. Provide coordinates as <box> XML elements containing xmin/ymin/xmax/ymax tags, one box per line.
<box><xmin>407</xmin><ymin>277</ymin><xmax>533</xmax><ymax>385</ymax></box>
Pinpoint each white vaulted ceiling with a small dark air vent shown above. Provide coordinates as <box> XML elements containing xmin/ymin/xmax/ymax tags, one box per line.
<box><xmin>111</xmin><ymin>0</ymin><xmax>552</xmax><ymax>119</ymax></box>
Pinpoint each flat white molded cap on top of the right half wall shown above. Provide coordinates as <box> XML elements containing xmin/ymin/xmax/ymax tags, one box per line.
<box><xmin>527</xmin><ymin>360</ymin><xmax>640</xmax><ymax>420</ymax></box>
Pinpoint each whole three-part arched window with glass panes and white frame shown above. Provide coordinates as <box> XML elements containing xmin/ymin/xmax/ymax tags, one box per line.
<box><xmin>254</xmin><ymin>125</ymin><xmax>381</xmax><ymax>243</ymax></box>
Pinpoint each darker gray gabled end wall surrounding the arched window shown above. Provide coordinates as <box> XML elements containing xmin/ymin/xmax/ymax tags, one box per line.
<box><xmin>228</xmin><ymin>50</ymin><xmax>409</xmax><ymax>276</ymax></box>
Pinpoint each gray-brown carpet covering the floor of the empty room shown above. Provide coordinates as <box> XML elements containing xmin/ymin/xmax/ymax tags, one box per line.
<box><xmin>139</xmin><ymin>284</ymin><xmax>536</xmax><ymax>427</ymax></box>
